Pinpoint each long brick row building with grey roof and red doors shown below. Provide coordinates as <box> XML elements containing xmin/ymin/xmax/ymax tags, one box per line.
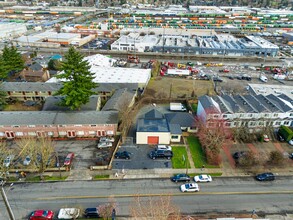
<box><xmin>0</xmin><ymin>111</ymin><xmax>118</xmax><ymax>139</ymax></box>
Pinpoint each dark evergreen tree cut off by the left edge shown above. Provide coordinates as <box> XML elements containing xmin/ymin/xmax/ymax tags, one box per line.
<box><xmin>0</xmin><ymin>46</ymin><xmax>24</xmax><ymax>79</ymax></box>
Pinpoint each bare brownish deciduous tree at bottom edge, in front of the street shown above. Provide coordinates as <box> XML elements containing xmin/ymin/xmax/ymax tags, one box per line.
<box><xmin>130</xmin><ymin>195</ymin><xmax>180</xmax><ymax>220</ymax></box>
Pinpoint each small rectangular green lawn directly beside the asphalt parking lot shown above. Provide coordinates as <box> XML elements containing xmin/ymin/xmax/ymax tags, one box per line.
<box><xmin>172</xmin><ymin>146</ymin><xmax>190</xmax><ymax>169</ymax></box>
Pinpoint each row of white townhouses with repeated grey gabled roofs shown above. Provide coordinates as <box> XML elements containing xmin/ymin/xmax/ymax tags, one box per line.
<box><xmin>197</xmin><ymin>94</ymin><xmax>293</xmax><ymax>130</ymax></box>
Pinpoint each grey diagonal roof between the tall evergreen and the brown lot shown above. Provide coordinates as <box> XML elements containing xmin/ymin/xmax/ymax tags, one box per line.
<box><xmin>102</xmin><ymin>88</ymin><xmax>135</xmax><ymax>111</ymax></box>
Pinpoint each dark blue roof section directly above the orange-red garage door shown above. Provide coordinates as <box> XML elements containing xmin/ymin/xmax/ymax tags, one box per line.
<box><xmin>136</xmin><ymin>118</ymin><xmax>170</xmax><ymax>132</ymax></box>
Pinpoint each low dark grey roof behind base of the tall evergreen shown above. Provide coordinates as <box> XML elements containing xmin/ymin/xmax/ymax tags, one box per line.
<box><xmin>42</xmin><ymin>95</ymin><xmax>99</xmax><ymax>111</ymax></box>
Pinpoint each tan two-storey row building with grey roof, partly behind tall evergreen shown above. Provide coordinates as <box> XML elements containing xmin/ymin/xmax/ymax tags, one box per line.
<box><xmin>1</xmin><ymin>82</ymin><xmax>138</xmax><ymax>101</ymax></box>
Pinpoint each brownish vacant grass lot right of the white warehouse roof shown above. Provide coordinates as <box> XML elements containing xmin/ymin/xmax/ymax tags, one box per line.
<box><xmin>146</xmin><ymin>77</ymin><xmax>215</xmax><ymax>99</ymax></box>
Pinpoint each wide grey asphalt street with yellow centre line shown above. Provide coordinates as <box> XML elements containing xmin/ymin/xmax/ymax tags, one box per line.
<box><xmin>0</xmin><ymin>177</ymin><xmax>293</xmax><ymax>220</ymax></box>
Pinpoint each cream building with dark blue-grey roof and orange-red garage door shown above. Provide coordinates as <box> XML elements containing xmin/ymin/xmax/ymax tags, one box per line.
<box><xmin>136</xmin><ymin>109</ymin><xmax>195</xmax><ymax>144</ymax></box>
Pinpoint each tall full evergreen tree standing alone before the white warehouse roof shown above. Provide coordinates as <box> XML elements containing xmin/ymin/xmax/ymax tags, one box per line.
<box><xmin>56</xmin><ymin>47</ymin><xmax>97</xmax><ymax>110</ymax></box>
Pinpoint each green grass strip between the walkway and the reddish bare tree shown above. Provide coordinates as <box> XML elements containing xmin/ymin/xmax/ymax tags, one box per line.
<box><xmin>187</xmin><ymin>136</ymin><xmax>218</xmax><ymax>168</ymax></box>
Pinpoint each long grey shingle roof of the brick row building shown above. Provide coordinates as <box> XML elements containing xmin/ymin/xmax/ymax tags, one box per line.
<box><xmin>0</xmin><ymin>111</ymin><xmax>118</xmax><ymax>126</ymax></box>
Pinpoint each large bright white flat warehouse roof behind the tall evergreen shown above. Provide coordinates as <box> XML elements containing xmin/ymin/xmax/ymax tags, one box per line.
<box><xmin>47</xmin><ymin>54</ymin><xmax>151</xmax><ymax>85</ymax></box>
